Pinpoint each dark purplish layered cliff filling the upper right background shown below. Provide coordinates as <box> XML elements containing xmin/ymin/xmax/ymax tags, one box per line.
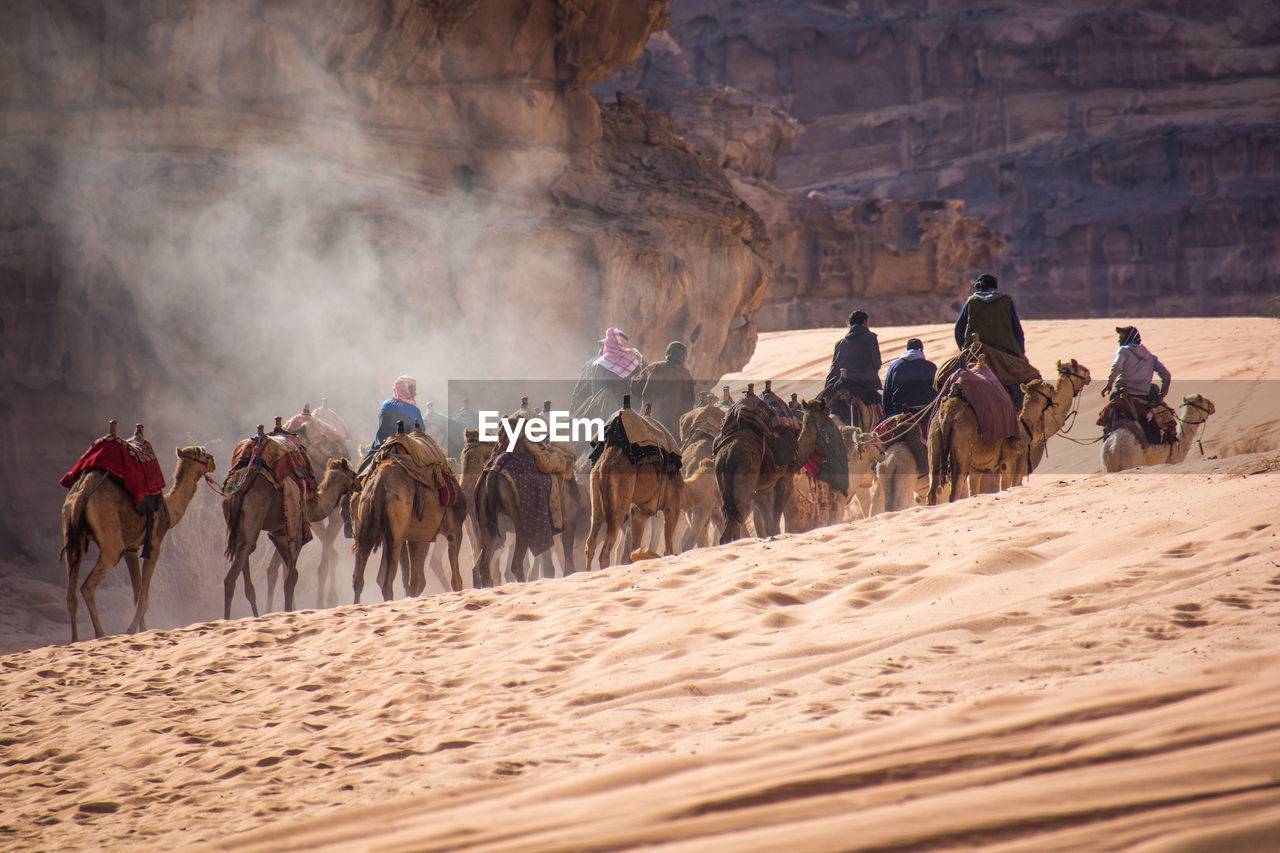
<box><xmin>669</xmin><ymin>0</ymin><xmax>1280</xmax><ymax>316</ymax></box>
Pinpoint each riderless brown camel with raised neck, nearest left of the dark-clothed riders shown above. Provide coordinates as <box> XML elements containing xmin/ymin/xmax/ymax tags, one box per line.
<box><xmin>716</xmin><ymin>394</ymin><xmax>831</xmax><ymax>544</ymax></box>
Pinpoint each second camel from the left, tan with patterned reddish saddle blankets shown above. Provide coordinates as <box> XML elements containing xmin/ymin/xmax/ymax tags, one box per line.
<box><xmin>223</xmin><ymin>459</ymin><xmax>356</xmax><ymax>619</ymax></box>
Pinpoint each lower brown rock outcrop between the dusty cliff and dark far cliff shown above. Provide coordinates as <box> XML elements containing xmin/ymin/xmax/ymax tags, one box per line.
<box><xmin>594</xmin><ymin>33</ymin><xmax>1001</xmax><ymax>330</ymax></box>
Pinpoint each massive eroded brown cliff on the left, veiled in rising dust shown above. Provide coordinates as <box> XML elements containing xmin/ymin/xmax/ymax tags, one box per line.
<box><xmin>0</xmin><ymin>0</ymin><xmax>769</xmax><ymax>564</ymax></box>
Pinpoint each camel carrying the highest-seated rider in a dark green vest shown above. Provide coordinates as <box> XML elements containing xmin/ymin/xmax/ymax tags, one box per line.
<box><xmin>925</xmin><ymin>373</ymin><xmax>1053</xmax><ymax>506</ymax></box>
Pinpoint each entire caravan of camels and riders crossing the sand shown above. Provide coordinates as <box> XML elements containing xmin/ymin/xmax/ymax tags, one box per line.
<box><xmin>60</xmin><ymin>301</ymin><xmax>1213</xmax><ymax>642</ymax></box>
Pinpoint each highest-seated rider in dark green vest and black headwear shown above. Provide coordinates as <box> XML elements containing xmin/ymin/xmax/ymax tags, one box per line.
<box><xmin>955</xmin><ymin>273</ymin><xmax>1041</xmax><ymax>409</ymax></box>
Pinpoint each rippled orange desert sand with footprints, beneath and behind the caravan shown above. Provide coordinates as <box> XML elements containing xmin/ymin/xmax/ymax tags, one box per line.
<box><xmin>0</xmin><ymin>318</ymin><xmax>1280</xmax><ymax>850</ymax></box>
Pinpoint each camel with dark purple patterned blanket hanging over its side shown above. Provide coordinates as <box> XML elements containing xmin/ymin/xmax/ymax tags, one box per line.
<box><xmin>471</xmin><ymin>455</ymin><xmax>582</xmax><ymax>587</ymax></box>
